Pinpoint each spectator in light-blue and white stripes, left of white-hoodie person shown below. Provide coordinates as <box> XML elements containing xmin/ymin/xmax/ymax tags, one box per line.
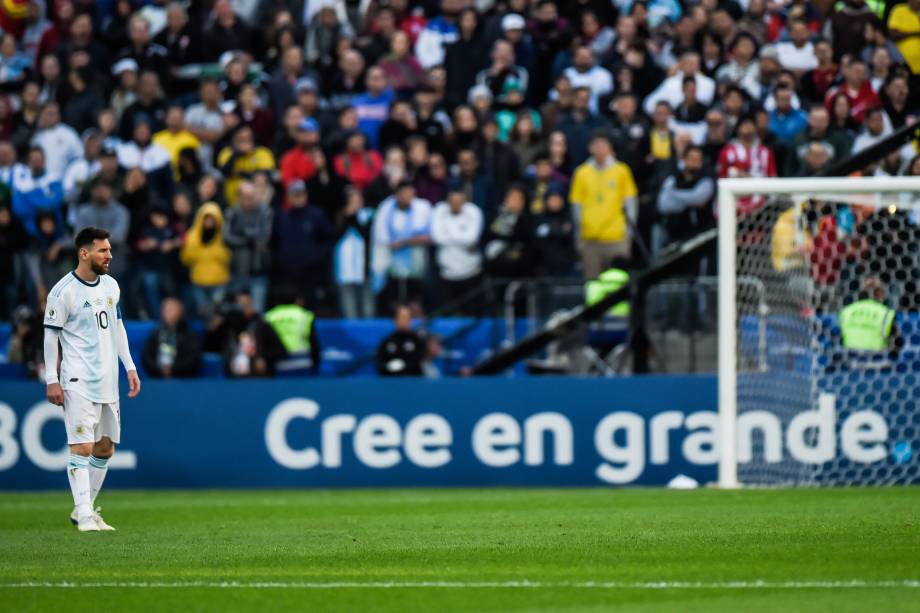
<box><xmin>373</xmin><ymin>179</ymin><xmax>431</xmax><ymax>310</ymax></box>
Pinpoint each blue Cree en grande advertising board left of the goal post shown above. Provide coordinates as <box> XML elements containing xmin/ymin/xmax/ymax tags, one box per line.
<box><xmin>0</xmin><ymin>376</ymin><xmax>718</xmax><ymax>490</ymax></box>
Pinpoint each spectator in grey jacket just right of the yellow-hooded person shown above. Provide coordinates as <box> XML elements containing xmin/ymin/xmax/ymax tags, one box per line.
<box><xmin>224</xmin><ymin>181</ymin><xmax>274</xmax><ymax>312</ymax></box>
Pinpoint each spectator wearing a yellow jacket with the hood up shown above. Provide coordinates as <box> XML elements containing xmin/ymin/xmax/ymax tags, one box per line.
<box><xmin>180</xmin><ymin>202</ymin><xmax>231</xmax><ymax>317</ymax></box>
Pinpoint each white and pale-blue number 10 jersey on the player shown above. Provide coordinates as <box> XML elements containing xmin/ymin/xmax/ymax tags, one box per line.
<box><xmin>45</xmin><ymin>272</ymin><xmax>121</xmax><ymax>404</ymax></box>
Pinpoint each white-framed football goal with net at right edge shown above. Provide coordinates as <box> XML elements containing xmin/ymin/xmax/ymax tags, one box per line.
<box><xmin>719</xmin><ymin>177</ymin><xmax>920</xmax><ymax>487</ymax></box>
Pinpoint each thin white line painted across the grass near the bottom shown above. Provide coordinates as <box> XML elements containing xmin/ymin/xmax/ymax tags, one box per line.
<box><xmin>0</xmin><ymin>579</ymin><xmax>920</xmax><ymax>590</ymax></box>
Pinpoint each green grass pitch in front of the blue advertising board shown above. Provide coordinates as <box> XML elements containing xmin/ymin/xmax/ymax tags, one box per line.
<box><xmin>0</xmin><ymin>488</ymin><xmax>920</xmax><ymax>613</ymax></box>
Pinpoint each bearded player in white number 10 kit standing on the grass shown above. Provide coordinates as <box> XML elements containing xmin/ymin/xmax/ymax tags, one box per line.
<box><xmin>45</xmin><ymin>228</ymin><xmax>141</xmax><ymax>532</ymax></box>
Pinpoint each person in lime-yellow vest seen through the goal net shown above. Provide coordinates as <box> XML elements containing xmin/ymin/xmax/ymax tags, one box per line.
<box><xmin>840</xmin><ymin>278</ymin><xmax>896</xmax><ymax>353</ymax></box>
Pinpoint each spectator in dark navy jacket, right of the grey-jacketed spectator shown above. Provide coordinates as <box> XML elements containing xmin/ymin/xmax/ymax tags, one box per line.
<box><xmin>274</xmin><ymin>180</ymin><xmax>335</xmax><ymax>308</ymax></box>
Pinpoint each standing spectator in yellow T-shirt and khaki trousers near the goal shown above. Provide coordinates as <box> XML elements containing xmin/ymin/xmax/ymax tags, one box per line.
<box><xmin>569</xmin><ymin>132</ymin><xmax>638</xmax><ymax>280</ymax></box>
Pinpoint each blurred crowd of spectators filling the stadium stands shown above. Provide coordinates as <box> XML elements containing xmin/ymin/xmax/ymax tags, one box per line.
<box><xmin>0</xmin><ymin>0</ymin><xmax>920</xmax><ymax>350</ymax></box>
